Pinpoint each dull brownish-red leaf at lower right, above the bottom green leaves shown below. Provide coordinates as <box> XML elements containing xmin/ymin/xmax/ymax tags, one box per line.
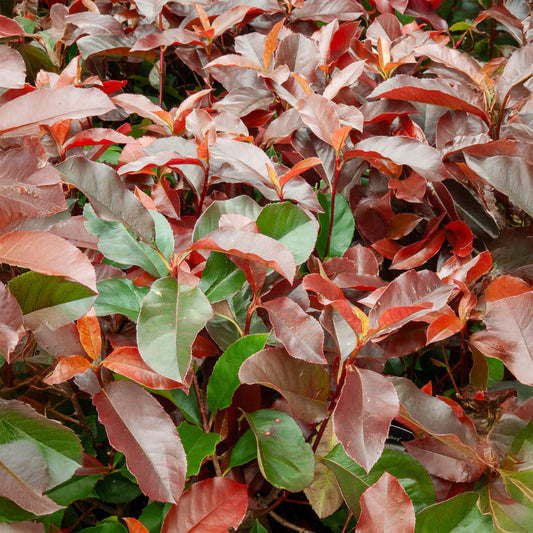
<box><xmin>403</xmin><ymin>437</ymin><xmax>486</xmax><ymax>483</ymax></box>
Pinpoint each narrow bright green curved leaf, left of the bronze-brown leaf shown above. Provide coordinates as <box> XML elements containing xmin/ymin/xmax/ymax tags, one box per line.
<box><xmin>207</xmin><ymin>333</ymin><xmax>269</xmax><ymax>413</ymax></box>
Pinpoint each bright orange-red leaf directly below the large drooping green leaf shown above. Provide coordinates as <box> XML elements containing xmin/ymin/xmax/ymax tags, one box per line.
<box><xmin>102</xmin><ymin>346</ymin><xmax>182</xmax><ymax>390</ymax></box>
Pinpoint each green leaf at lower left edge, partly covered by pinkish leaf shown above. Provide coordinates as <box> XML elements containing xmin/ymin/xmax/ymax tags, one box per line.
<box><xmin>0</xmin><ymin>399</ymin><xmax>82</xmax><ymax>488</ymax></box>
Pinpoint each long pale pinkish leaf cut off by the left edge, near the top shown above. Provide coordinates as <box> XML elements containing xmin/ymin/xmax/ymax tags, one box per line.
<box><xmin>0</xmin><ymin>85</ymin><xmax>115</xmax><ymax>137</ymax></box>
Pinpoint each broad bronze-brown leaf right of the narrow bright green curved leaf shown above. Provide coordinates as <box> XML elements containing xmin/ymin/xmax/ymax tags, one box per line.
<box><xmin>239</xmin><ymin>348</ymin><xmax>329</xmax><ymax>424</ymax></box>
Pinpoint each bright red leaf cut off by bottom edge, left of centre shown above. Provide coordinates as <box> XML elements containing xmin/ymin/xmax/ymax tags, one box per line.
<box><xmin>161</xmin><ymin>477</ymin><xmax>248</xmax><ymax>533</ymax></box>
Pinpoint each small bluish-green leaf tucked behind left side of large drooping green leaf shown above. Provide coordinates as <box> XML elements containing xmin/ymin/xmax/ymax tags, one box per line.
<box><xmin>94</xmin><ymin>278</ymin><xmax>150</xmax><ymax>322</ymax></box>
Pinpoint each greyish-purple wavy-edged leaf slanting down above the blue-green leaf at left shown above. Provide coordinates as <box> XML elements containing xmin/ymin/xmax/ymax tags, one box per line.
<box><xmin>57</xmin><ymin>157</ymin><xmax>155</xmax><ymax>242</ymax></box>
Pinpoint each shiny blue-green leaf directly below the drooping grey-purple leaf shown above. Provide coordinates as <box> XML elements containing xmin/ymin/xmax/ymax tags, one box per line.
<box><xmin>83</xmin><ymin>204</ymin><xmax>168</xmax><ymax>277</ymax></box>
